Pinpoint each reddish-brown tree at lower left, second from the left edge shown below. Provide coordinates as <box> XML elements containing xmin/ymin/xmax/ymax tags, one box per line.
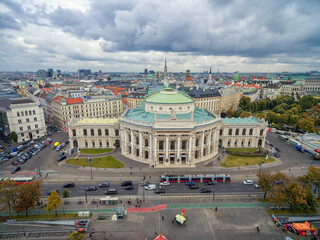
<box><xmin>14</xmin><ymin>181</ymin><xmax>41</xmax><ymax>216</ymax></box>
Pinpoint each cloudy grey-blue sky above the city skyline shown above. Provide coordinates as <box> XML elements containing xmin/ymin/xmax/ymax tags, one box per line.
<box><xmin>0</xmin><ymin>0</ymin><xmax>320</xmax><ymax>72</ymax></box>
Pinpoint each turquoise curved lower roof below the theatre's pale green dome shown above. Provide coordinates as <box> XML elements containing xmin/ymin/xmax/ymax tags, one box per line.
<box><xmin>124</xmin><ymin>107</ymin><xmax>216</xmax><ymax>123</ymax></box>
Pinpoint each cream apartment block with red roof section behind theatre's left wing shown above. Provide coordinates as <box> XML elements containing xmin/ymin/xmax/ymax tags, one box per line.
<box><xmin>51</xmin><ymin>95</ymin><xmax>123</xmax><ymax>131</ymax></box>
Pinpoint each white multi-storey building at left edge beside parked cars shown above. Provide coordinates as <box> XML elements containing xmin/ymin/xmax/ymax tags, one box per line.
<box><xmin>0</xmin><ymin>99</ymin><xmax>46</xmax><ymax>142</ymax></box>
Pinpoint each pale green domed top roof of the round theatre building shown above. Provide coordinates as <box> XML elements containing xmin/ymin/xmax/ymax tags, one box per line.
<box><xmin>146</xmin><ymin>88</ymin><xmax>193</xmax><ymax>104</ymax></box>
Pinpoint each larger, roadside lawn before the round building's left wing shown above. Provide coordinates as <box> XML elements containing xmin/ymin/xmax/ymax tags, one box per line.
<box><xmin>66</xmin><ymin>156</ymin><xmax>124</xmax><ymax>168</ymax></box>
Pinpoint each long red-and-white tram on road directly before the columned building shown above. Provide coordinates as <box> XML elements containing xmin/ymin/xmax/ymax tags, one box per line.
<box><xmin>160</xmin><ymin>174</ymin><xmax>231</xmax><ymax>183</ymax></box>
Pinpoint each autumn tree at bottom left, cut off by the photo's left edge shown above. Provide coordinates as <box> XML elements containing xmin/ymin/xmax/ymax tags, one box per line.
<box><xmin>0</xmin><ymin>180</ymin><xmax>17</xmax><ymax>216</ymax></box>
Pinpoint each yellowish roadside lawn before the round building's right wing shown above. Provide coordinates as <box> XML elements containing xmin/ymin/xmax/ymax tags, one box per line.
<box><xmin>220</xmin><ymin>155</ymin><xmax>275</xmax><ymax>167</ymax></box>
